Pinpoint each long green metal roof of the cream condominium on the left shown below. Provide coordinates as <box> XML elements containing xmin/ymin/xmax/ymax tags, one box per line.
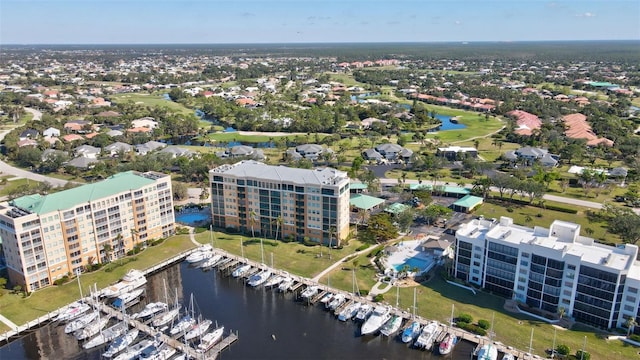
<box><xmin>12</xmin><ymin>171</ymin><xmax>155</xmax><ymax>214</ymax></box>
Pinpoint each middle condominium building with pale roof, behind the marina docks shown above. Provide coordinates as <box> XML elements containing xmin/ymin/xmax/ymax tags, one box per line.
<box><xmin>209</xmin><ymin>160</ymin><xmax>349</xmax><ymax>246</ymax></box>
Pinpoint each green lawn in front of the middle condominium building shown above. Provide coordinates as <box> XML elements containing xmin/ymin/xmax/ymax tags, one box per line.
<box><xmin>196</xmin><ymin>231</ymin><xmax>362</xmax><ymax>278</ymax></box>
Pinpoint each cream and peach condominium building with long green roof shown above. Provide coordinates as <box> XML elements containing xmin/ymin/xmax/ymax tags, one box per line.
<box><xmin>0</xmin><ymin>171</ymin><xmax>175</xmax><ymax>291</ymax></box>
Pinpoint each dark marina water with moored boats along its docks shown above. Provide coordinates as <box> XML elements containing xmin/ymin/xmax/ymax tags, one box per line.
<box><xmin>0</xmin><ymin>262</ymin><xmax>473</xmax><ymax>360</ymax></box>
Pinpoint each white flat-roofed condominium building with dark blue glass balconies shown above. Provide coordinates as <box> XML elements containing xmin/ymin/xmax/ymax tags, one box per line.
<box><xmin>454</xmin><ymin>217</ymin><xmax>640</xmax><ymax>328</ymax></box>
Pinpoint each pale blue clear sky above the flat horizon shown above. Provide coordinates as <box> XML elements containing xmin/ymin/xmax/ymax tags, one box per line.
<box><xmin>0</xmin><ymin>0</ymin><xmax>640</xmax><ymax>44</ymax></box>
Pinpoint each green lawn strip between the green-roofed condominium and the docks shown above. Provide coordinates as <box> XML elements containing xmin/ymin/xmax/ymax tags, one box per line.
<box><xmin>0</xmin><ymin>235</ymin><xmax>194</xmax><ymax>324</ymax></box>
